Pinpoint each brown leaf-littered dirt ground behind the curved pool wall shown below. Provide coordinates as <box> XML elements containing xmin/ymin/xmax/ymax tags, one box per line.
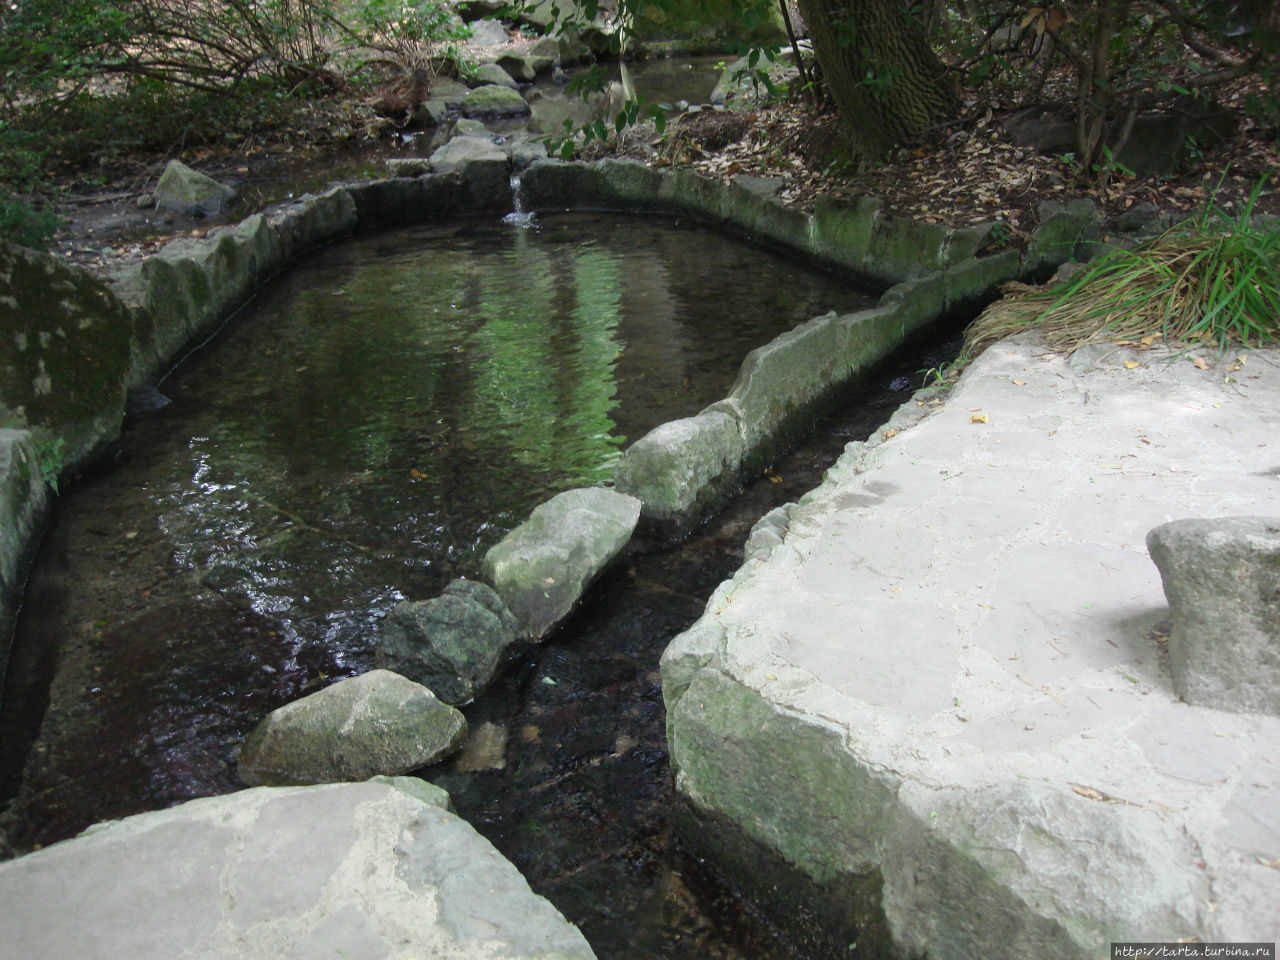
<box><xmin>45</xmin><ymin>62</ymin><xmax>1280</xmax><ymax>273</ymax></box>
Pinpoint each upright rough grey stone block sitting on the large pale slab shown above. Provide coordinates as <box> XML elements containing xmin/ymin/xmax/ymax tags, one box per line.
<box><xmin>1147</xmin><ymin>517</ymin><xmax>1280</xmax><ymax>716</ymax></box>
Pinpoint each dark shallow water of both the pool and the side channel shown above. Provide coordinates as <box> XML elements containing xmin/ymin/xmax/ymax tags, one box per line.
<box><xmin>0</xmin><ymin>207</ymin><xmax>955</xmax><ymax>960</ymax></box>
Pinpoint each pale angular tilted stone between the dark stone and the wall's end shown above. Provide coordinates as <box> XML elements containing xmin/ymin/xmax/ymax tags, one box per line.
<box><xmin>483</xmin><ymin>486</ymin><xmax>640</xmax><ymax>640</ymax></box>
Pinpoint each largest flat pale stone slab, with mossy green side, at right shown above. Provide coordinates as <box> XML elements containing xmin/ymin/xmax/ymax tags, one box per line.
<box><xmin>663</xmin><ymin>340</ymin><xmax>1280</xmax><ymax>959</ymax></box>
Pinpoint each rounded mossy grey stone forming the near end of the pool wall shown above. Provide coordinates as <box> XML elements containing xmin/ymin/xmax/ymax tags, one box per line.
<box><xmin>613</xmin><ymin>408</ymin><xmax>746</xmax><ymax>532</ymax></box>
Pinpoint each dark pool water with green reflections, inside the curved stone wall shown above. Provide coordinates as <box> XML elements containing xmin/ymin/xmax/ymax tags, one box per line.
<box><xmin>0</xmin><ymin>216</ymin><xmax>867</xmax><ymax>845</ymax></box>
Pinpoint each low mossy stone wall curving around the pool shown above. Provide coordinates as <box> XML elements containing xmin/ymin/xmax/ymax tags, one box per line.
<box><xmin>0</xmin><ymin>154</ymin><xmax>1094</xmax><ymax>706</ymax></box>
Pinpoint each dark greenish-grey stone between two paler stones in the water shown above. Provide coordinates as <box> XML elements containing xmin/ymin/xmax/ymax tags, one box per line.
<box><xmin>378</xmin><ymin>580</ymin><xmax>526</xmax><ymax>704</ymax></box>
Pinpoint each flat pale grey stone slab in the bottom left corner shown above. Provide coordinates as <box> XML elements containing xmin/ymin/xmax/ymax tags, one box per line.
<box><xmin>0</xmin><ymin>777</ymin><xmax>594</xmax><ymax>960</ymax></box>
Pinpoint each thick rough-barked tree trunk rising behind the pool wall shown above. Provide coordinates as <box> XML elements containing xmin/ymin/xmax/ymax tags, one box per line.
<box><xmin>799</xmin><ymin>0</ymin><xmax>959</xmax><ymax>160</ymax></box>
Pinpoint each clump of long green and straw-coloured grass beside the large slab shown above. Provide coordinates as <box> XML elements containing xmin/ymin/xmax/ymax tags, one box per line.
<box><xmin>961</xmin><ymin>182</ymin><xmax>1280</xmax><ymax>358</ymax></box>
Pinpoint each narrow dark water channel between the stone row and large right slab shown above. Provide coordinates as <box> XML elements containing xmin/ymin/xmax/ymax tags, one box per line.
<box><xmin>424</xmin><ymin>325</ymin><xmax>960</xmax><ymax>960</ymax></box>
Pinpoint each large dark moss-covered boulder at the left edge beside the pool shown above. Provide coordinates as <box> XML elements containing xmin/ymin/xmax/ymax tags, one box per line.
<box><xmin>0</xmin><ymin>241</ymin><xmax>133</xmax><ymax>476</ymax></box>
